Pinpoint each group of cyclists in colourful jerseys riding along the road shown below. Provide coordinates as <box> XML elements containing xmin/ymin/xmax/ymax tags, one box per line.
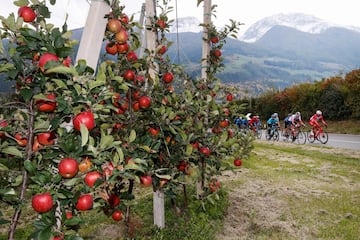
<box><xmin>234</xmin><ymin>110</ymin><xmax>327</xmax><ymax>141</ymax></box>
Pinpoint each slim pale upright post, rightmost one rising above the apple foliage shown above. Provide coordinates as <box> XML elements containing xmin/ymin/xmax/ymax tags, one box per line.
<box><xmin>201</xmin><ymin>0</ymin><xmax>211</xmax><ymax>81</ymax></box>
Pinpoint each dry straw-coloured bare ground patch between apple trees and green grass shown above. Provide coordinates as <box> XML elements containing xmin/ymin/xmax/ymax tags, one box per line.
<box><xmin>217</xmin><ymin>143</ymin><xmax>360</xmax><ymax>240</ymax></box>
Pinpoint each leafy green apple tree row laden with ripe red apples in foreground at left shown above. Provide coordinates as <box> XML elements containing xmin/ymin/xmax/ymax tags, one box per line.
<box><xmin>0</xmin><ymin>0</ymin><xmax>255</xmax><ymax>239</ymax></box>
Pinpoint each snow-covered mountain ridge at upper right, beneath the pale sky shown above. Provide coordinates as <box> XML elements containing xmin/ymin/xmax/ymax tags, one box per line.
<box><xmin>239</xmin><ymin>13</ymin><xmax>360</xmax><ymax>42</ymax></box>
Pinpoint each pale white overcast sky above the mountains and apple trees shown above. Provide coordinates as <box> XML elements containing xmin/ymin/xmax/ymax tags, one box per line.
<box><xmin>0</xmin><ymin>0</ymin><xmax>360</xmax><ymax>34</ymax></box>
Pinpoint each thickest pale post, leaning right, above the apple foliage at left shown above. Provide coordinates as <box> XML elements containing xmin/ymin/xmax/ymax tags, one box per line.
<box><xmin>76</xmin><ymin>0</ymin><xmax>112</xmax><ymax>71</ymax></box>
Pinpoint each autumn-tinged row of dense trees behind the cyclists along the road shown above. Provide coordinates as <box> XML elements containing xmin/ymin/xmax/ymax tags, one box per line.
<box><xmin>240</xmin><ymin>69</ymin><xmax>360</xmax><ymax>120</ymax></box>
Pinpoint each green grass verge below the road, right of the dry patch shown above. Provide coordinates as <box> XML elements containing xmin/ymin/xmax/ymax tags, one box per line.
<box><xmin>236</xmin><ymin>142</ymin><xmax>360</xmax><ymax>240</ymax></box>
